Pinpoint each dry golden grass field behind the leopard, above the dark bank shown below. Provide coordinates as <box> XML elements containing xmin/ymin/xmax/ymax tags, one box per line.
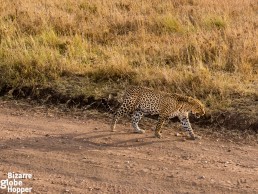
<box><xmin>0</xmin><ymin>0</ymin><xmax>258</xmax><ymax>109</ymax></box>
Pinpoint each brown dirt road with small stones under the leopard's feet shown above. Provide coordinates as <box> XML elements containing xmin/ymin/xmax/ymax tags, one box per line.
<box><xmin>0</xmin><ymin>101</ymin><xmax>258</xmax><ymax>194</ymax></box>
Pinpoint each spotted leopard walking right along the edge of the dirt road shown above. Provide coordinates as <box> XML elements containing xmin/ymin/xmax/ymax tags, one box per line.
<box><xmin>111</xmin><ymin>86</ymin><xmax>205</xmax><ymax>140</ymax></box>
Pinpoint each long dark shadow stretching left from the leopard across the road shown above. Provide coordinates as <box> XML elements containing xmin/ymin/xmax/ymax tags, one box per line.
<box><xmin>0</xmin><ymin>131</ymin><xmax>171</xmax><ymax>152</ymax></box>
